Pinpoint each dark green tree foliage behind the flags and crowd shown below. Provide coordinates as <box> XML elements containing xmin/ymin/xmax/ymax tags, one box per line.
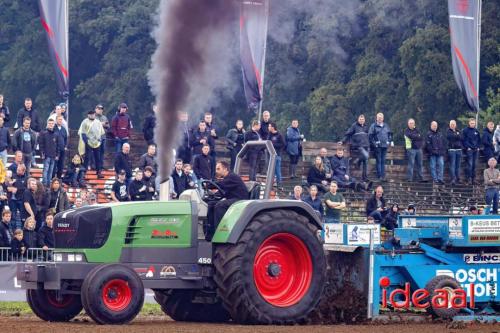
<box><xmin>0</xmin><ymin>0</ymin><xmax>500</xmax><ymax>140</ymax></box>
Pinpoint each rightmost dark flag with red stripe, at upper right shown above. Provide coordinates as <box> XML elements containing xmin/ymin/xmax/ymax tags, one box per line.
<box><xmin>448</xmin><ymin>0</ymin><xmax>481</xmax><ymax>112</ymax></box>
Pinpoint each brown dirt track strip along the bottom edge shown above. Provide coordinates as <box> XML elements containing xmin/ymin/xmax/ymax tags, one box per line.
<box><xmin>0</xmin><ymin>317</ymin><xmax>500</xmax><ymax>333</ymax></box>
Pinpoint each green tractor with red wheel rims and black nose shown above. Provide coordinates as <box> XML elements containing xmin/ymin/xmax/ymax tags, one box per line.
<box><xmin>17</xmin><ymin>141</ymin><xmax>326</xmax><ymax>324</ymax></box>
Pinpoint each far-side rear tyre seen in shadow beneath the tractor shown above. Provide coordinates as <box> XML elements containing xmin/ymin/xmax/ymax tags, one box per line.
<box><xmin>153</xmin><ymin>289</ymin><xmax>230</xmax><ymax>323</ymax></box>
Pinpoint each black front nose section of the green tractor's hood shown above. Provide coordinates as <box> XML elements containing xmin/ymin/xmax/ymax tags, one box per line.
<box><xmin>54</xmin><ymin>205</ymin><xmax>112</xmax><ymax>249</ymax></box>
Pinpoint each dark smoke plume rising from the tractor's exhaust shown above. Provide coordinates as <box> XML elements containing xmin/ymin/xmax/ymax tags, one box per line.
<box><xmin>149</xmin><ymin>0</ymin><xmax>237</xmax><ymax>182</ymax></box>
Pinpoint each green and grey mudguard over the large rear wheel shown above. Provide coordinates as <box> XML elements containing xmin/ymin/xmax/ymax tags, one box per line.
<box><xmin>212</xmin><ymin>200</ymin><xmax>323</xmax><ymax>244</ymax></box>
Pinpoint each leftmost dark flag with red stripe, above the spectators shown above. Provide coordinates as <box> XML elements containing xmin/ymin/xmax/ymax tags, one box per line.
<box><xmin>38</xmin><ymin>0</ymin><xmax>69</xmax><ymax>98</ymax></box>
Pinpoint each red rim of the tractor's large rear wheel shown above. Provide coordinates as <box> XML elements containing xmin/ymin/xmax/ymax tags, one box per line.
<box><xmin>253</xmin><ymin>233</ymin><xmax>313</xmax><ymax>307</ymax></box>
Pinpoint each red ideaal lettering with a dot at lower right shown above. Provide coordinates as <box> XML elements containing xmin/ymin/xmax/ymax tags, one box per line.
<box><xmin>379</xmin><ymin>276</ymin><xmax>475</xmax><ymax>309</ymax></box>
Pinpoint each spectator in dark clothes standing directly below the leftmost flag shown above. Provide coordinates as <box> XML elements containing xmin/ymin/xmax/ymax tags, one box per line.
<box><xmin>38</xmin><ymin>119</ymin><xmax>64</xmax><ymax>186</ymax></box>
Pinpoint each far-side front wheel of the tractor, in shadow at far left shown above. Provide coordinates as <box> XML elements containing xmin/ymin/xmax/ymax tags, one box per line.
<box><xmin>26</xmin><ymin>289</ymin><xmax>82</xmax><ymax>321</ymax></box>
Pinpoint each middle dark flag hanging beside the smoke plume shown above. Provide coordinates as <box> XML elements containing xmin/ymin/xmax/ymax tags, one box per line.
<box><xmin>240</xmin><ymin>0</ymin><xmax>269</xmax><ymax>116</ymax></box>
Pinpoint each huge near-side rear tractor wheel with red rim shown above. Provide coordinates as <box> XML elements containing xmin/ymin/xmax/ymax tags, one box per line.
<box><xmin>214</xmin><ymin>209</ymin><xmax>326</xmax><ymax>325</ymax></box>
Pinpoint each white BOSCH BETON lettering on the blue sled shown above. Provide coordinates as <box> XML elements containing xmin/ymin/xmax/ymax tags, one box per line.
<box><xmin>436</xmin><ymin>267</ymin><xmax>499</xmax><ymax>297</ymax></box>
